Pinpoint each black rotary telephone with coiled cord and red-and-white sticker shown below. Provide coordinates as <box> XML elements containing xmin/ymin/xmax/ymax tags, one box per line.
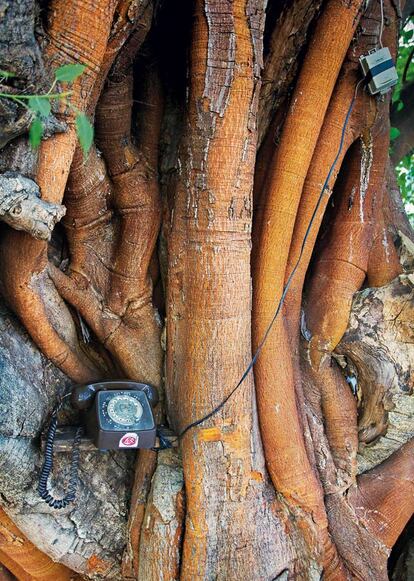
<box><xmin>38</xmin><ymin>381</ymin><xmax>158</xmax><ymax>509</ymax></box>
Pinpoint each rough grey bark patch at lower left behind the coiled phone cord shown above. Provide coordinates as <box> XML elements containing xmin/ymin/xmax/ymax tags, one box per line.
<box><xmin>0</xmin><ymin>307</ymin><xmax>133</xmax><ymax>579</ymax></box>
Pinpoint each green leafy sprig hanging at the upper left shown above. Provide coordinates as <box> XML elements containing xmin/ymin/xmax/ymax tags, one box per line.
<box><xmin>0</xmin><ymin>64</ymin><xmax>93</xmax><ymax>157</ymax></box>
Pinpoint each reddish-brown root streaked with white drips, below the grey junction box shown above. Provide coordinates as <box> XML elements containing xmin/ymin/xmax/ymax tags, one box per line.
<box><xmin>306</xmin><ymin>127</ymin><xmax>389</xmax><ymax>369</ymax></box>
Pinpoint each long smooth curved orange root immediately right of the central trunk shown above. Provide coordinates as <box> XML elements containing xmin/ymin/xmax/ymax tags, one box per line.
<box><xmin>252</xmin><ymin>1</ymin><xmax>360</xmax><ymax>564</ymax></box>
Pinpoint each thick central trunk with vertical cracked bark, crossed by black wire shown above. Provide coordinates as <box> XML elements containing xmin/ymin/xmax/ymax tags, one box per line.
<box><xmin>167</xmin><ymin>0</ymin><xmax>294</xmax><ymax>580</ymax></box>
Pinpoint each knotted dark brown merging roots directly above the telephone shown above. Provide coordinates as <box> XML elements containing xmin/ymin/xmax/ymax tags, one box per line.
<box><xmin>50</xmin><ymin>63</ymin><xmax>161</xmax><ymax>386</ymax></box>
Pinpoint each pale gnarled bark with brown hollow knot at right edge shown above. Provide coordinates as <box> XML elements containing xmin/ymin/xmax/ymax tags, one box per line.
<box><xmin>336</xmin><ymin>274</ymin><xmax>414</xmax><ymax>472</ymax></box>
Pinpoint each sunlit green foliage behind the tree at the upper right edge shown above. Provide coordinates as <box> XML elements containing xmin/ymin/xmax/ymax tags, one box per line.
<box><xmin>390</xmin><ymin>17</ymin><xmax>414</xmax><ymax>225</ymax></box>
